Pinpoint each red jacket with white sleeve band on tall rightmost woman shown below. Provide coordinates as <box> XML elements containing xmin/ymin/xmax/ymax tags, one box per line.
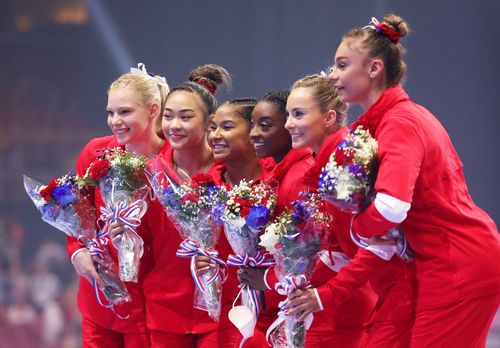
<box><xmin>352</xmin><ymin>85</ymin><xmax>500</xmax><ymax>309</ymax></box>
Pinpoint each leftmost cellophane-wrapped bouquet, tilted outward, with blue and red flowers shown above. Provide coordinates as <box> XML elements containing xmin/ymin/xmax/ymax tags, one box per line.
<box><xmin>24</xmin><ymin>173</ymin><xmax>131</xmax><ymax>307</ymax></box>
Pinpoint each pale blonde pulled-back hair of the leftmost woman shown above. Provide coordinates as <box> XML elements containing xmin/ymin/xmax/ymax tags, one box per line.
<box><xmin>108</xmin><ymin>72</ymin><xmax>170</xmax><ymax>134</ymax></box>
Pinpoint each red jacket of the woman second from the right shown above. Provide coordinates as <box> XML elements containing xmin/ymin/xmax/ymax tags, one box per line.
<box><xmin>306</xmin><ymin>127</ymin><xmax>416</xmax><ymax>328</ymax></box>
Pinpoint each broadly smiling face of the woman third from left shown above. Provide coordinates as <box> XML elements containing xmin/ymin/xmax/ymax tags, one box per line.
<box><xmin>208</xmin><ymin>104</ymin><xmax>254</xmax><ymax>161</ymax></box>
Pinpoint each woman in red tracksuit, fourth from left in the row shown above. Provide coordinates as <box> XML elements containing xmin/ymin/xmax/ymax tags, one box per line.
<box><xmin>239</xmin><ymin>85</ymin><xmax>374</xmax><ymax>347</ymax></box>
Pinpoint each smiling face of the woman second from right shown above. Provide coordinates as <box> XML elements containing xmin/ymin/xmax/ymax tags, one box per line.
<box><xmin>285</xmin><ymin>87</ymin><xmax>327</xmax><ymax>152</ymax></box>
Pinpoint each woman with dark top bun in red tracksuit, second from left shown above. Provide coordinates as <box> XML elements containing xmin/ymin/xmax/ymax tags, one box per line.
<box><xmin>130</xmin><ymin>65</ymin><xmax>243</xmax><ymax>348</ymax></box>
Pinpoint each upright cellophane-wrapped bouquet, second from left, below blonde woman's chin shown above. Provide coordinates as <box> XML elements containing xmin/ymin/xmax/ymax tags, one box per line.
<box><xmin>84</xmin><ymin>148</ymin><xmax>149</xmax><ymax>282</ymax></box>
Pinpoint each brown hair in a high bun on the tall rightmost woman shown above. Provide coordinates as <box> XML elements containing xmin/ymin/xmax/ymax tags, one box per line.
<box><xmin>342</xmin><ymin>14</ymin><xmax>410</xmax><ymax>87</ymax></box>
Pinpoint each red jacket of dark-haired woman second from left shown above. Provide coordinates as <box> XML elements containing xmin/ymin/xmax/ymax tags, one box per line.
<box><xmin>144</xmin><ymin>149</ymin><xmax>238</xmax><ymax>335</ymax></box>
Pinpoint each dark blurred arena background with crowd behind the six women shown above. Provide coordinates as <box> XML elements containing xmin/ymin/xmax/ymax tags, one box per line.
<box><xmin>0</xmin><ymin>0</ymin><xmax>500</xmax><ymax>348</ymax></box>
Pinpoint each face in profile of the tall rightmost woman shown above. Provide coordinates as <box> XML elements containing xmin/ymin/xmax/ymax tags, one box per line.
<box><xmin>328</xmin><ymin>39</ymin><xmax>373</xmax><ymax>105</ymax></box>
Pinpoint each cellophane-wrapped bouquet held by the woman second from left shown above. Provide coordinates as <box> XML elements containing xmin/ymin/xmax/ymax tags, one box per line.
<box><xmin>146</xmin><ymin>158</ymin><xmax>227</xmax><ymax>321</ymax></box>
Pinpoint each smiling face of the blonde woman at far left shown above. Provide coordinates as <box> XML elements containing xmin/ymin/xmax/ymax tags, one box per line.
<box><xmin>106</xmin><ymin>86</ymin><xmax>158</xmax><ymax>145</ymax></box>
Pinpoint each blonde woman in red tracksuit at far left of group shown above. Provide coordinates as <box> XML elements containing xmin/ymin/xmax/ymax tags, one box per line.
<box><xmin>67</xmin><ymin>64</ymin><xmax>168</xmax><ymax>347</ymax></box>
